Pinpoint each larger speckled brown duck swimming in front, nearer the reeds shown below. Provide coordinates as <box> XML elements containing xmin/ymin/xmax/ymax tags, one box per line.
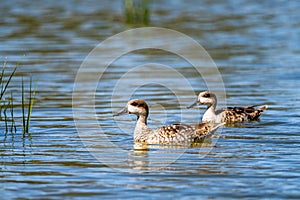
<box><xmin>115</xmin><ymin>99</ymin><xmax>223</xmax><ymax>144</ymax></box>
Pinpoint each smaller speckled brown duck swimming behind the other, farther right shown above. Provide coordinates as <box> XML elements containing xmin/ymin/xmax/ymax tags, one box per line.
<box><xmin>188</xmin><ymin>91</ymin><xmax>268</xmax><ymax>123</ymax></box>
